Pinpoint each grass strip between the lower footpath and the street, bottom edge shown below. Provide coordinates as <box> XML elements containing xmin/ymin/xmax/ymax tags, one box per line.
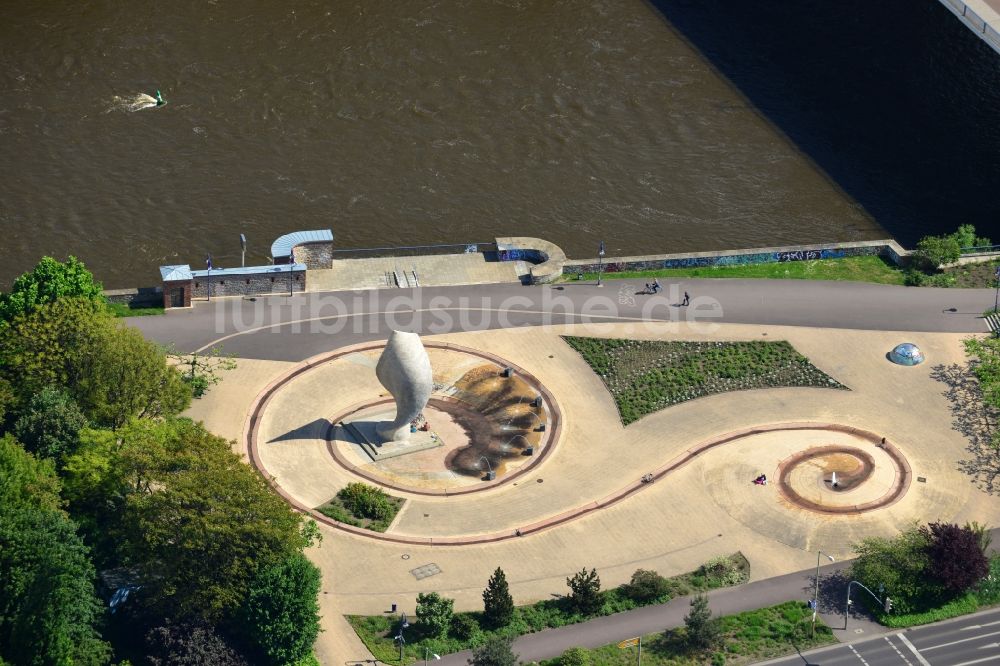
<box><xmin>541</xmin><ymin>601</ymin><xmax>837</xmax><ymax>666</ymax></box>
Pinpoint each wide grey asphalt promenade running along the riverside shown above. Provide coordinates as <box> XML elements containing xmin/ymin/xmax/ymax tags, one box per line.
<box><xmin>130</xmin><ymin>280</ymin><xmax>994</xmax><ymax>361</ymax></box>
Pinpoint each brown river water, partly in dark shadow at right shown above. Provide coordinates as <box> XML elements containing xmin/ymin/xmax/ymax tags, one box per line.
<box><xmin>0</xmin><ymin>0</ymin><xmax>1000</xmax><ymax>289</ymax></box>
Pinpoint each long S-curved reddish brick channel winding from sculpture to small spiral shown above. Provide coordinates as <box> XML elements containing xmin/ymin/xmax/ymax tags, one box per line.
<box><xmin>243</xmin><ymin>343</ymin><xmax>912</xmax><ymax>546</ymax></box>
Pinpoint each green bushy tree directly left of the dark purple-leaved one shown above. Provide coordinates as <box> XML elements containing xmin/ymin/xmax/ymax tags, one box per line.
<box><xmin>850</xmin><ymin>525</ymin><xmax>943</xmax><ymax>613</ymax></box>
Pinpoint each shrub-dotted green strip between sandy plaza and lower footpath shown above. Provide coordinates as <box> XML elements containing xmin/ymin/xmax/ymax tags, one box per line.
<box><xmin>347</xmin><ymin>553</ymin><xmax>750</xmax><ymax>663</ymax></box>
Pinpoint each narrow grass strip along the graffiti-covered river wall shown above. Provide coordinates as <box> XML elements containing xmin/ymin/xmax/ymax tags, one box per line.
<box><xmin>561</xmin><ymin>256</ymin><xmax>903</xmax><ymax>284</ymax></box>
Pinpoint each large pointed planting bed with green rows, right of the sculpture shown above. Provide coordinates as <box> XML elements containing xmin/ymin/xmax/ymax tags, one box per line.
<box><xmin>563</xmin><ymin>336</ymin><xmax>845</xmax><ymax>425</ymax></box>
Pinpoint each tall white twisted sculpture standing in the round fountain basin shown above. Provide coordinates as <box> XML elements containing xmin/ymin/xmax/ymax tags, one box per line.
<box><xmin>375</xmin><ymin>331</ymin><xmax>434</xmax><ymax>441</ymax></box>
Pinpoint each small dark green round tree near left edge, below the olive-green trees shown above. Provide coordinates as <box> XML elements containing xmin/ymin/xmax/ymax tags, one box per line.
<box><xmin>14</xmin><ymin>387</ymin><xmax>87</xmax><ymax>465</ymax></box>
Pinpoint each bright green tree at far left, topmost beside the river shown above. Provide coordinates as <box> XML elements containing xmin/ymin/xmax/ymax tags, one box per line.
<box><xmin>0</xmin><ymin>256</ymin><xmax>102</xmax><ymax>321</ymax></box>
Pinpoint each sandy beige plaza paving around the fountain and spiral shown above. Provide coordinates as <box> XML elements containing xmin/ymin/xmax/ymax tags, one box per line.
<box><xmin>184</xmin><ymin>324</ymin><xmax>1000</xmax><ymax>663</ymax></box>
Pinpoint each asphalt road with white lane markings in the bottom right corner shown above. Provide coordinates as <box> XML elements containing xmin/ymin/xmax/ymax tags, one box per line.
<box><xmin>767</xmin><ymin>608</ymin><xmax>1000</xmax><ymax>666</ymax></box>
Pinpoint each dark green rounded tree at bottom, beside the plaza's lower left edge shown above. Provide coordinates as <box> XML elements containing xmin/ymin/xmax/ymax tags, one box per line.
<box><xmin>238</xmin><ymin>552</ymin><xmax>318</xmax><ymax>664</ymax></box>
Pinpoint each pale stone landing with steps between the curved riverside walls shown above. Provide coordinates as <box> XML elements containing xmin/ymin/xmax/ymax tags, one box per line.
<box><xmin>306</xmin><ymin>253</ymin><xmax>528</xmax><ymax>292</ymax></box>
